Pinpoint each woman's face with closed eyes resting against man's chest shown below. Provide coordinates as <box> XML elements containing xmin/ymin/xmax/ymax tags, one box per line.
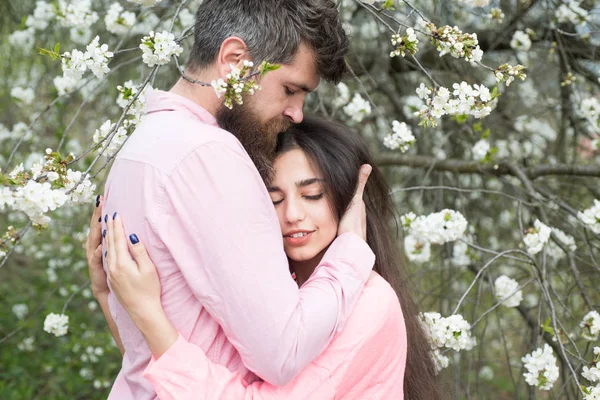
<box><xmin>269</xmin><ymin>149</ymin><xmax>338</xmax><ymax>262</ymax></box>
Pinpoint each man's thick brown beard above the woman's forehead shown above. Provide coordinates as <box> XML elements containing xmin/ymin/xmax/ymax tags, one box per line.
<box><xmin>216</xmin><ymin>99</ymin><xmax>291</xmax><ymax>182</ymax></box>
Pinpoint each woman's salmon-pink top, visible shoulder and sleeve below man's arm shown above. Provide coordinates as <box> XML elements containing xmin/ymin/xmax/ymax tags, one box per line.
<box><xmin>144</xmin><ymin>275</ymin><xmax>407</xmax><ymax>400</ymax></box>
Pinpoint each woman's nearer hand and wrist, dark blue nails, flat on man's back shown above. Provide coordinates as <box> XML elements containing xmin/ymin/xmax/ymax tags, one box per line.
<box><xmin>104</xmin><ymin>213</ymin><xmax>179</xmax><ymax>358</ymax></box>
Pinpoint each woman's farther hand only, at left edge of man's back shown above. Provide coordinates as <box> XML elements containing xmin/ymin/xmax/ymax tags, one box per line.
<box><xmin>85</xmin><ymin>195</ymin><xmax>109</xmax><ymax>299</ymax></box>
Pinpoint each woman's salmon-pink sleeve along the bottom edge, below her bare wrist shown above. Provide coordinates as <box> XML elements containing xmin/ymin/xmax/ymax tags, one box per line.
<box><xmin>144</xmin><ymin>335</ymin><xmax>335</xmax><ymax>400</ymax></box>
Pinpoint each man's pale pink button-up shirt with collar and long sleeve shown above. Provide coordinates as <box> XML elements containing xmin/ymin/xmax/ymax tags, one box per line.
<box><xmin>103</xmin><ymin>91</ymin><xmax>374</xmax><ymax>400</ymax></box>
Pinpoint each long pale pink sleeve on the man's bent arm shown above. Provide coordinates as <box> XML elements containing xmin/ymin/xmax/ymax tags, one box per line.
<box><xmin>149</xmin><ymin>142</ymin><xmax>375</xmax><ymax>386</ymax></box>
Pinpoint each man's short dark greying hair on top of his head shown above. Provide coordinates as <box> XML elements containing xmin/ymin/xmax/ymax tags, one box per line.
<box><xmin>188</xmin><ymin>0</ymin><xmax>349</xmax><ymax>83</ymax></box>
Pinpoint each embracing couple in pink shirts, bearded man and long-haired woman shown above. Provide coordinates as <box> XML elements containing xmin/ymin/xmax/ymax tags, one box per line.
<box><xmin>87</xmin><ymin>0</ymin><xmax>441</xmax><ymax>400</ymax></box>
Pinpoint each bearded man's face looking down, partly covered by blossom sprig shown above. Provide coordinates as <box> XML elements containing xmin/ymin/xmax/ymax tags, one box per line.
<box><xmin>216</xmin><ymin>44</ymin><xmax>320</xmax><ymax>180</ymax></box>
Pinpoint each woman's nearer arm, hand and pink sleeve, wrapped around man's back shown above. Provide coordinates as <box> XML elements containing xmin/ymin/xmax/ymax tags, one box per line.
<box><xmin>106</xmin><ymin>216</ymin><xmax>334</xmax><ymax>400</ymax></box>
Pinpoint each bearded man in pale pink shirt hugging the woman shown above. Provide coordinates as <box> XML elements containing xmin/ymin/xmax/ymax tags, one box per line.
<box><xmin>94</xmin><ymin>0</ymin><xmax>374</xmax><ymax>400</ymax></box>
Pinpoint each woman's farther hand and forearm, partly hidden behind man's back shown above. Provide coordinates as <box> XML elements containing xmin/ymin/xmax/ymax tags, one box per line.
<box><xmin>85</xmin><ymin>195</ymin><xmax>125</xmax><ymax>355</ymax></box>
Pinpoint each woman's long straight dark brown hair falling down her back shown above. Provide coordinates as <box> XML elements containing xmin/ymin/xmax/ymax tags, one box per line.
<box><xmin>276</xmin><ymin>116</ymin><xmax>442</xmax><ymax>400</ymax></box>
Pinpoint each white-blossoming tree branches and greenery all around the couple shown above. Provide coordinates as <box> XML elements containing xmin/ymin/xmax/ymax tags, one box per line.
<box><xmin>0</xmin><ymin>0</ymin><xmax>600</xmax><ymax>399</ymax></box>
